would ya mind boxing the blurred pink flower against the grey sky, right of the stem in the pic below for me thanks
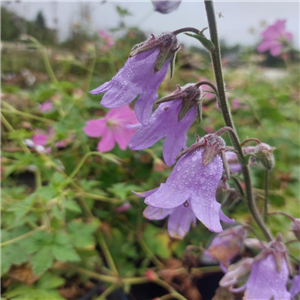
[257,20,293,56]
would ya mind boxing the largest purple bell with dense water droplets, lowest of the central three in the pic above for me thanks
[136,134,233,232]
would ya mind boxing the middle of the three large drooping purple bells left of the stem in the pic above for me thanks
[129,84,201,166]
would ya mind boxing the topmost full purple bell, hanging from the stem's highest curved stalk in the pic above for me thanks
[90,32,180,124]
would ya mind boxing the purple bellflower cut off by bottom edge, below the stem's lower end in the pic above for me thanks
[231,235,291,300]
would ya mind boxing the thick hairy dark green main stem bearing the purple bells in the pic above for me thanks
[204,0,272,241]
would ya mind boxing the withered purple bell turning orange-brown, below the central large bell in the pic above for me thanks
[205,225,247,268]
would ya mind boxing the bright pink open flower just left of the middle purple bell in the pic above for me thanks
[83,105,138,152]
